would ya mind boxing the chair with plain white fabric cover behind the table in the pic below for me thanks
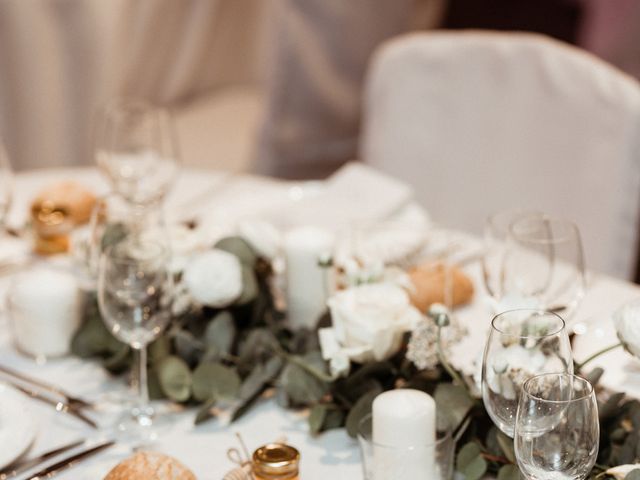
[360,31,640,278]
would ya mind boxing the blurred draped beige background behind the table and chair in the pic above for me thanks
[0,0,640,178]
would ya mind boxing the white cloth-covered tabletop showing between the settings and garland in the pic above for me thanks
[0,167,640,480]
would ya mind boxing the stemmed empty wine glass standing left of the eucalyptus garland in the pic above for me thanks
[98,239,172,429]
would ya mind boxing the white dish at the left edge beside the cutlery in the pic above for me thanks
[0,383,36,468]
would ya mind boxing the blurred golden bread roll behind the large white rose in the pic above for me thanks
[408,263,473,312]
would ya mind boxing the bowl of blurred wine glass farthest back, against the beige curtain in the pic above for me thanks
[94,99,178,205]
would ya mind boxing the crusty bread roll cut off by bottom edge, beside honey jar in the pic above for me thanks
[104,452,196,480]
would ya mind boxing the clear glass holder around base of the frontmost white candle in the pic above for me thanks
[358,415,456,480]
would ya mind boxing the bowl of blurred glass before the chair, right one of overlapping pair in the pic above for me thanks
[502,214,586,317]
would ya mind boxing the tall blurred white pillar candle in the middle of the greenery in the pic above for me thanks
[284,227,334,328]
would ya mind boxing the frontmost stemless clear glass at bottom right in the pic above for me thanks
[515,373,600,480]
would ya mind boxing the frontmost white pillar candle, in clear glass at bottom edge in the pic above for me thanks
[372,389,437,480]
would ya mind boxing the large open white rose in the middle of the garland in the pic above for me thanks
[320,283,422,376]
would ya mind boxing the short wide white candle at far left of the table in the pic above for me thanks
[8,267,82,359]
